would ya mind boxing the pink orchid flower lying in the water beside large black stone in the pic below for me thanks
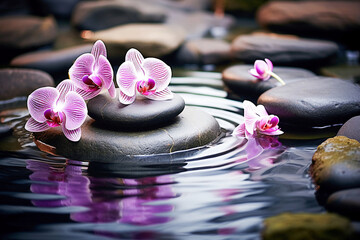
[233,100,283,138]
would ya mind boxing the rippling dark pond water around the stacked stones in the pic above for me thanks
[0,71,331,240]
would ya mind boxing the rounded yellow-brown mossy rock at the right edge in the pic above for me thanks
[311,136,360,192]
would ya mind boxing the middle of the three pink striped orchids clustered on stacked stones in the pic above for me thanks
[69,40,116,100]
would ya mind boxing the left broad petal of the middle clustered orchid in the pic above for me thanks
[69,53,95,89]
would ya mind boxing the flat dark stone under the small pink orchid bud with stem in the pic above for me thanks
[222,65,315,100]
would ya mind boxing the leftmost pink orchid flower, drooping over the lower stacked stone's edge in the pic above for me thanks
[25,80,87,142]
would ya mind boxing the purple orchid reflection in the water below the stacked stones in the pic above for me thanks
[27,160,176,225]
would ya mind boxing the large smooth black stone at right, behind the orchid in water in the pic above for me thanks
[258,77,360,127]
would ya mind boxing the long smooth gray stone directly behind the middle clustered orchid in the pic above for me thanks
[10,44,92,82]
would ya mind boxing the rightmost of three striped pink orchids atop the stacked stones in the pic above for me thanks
[116,48,173,104]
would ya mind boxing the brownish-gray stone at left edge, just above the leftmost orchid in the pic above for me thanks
[0,68,54,100]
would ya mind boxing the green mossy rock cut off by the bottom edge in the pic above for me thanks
[262,213,353,240]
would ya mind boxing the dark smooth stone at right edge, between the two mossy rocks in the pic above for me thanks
[325,188,360,219]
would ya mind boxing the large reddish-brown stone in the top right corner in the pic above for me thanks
[256,0,360,46]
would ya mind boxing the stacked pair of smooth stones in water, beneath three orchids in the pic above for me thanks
[34,91,220,165]
